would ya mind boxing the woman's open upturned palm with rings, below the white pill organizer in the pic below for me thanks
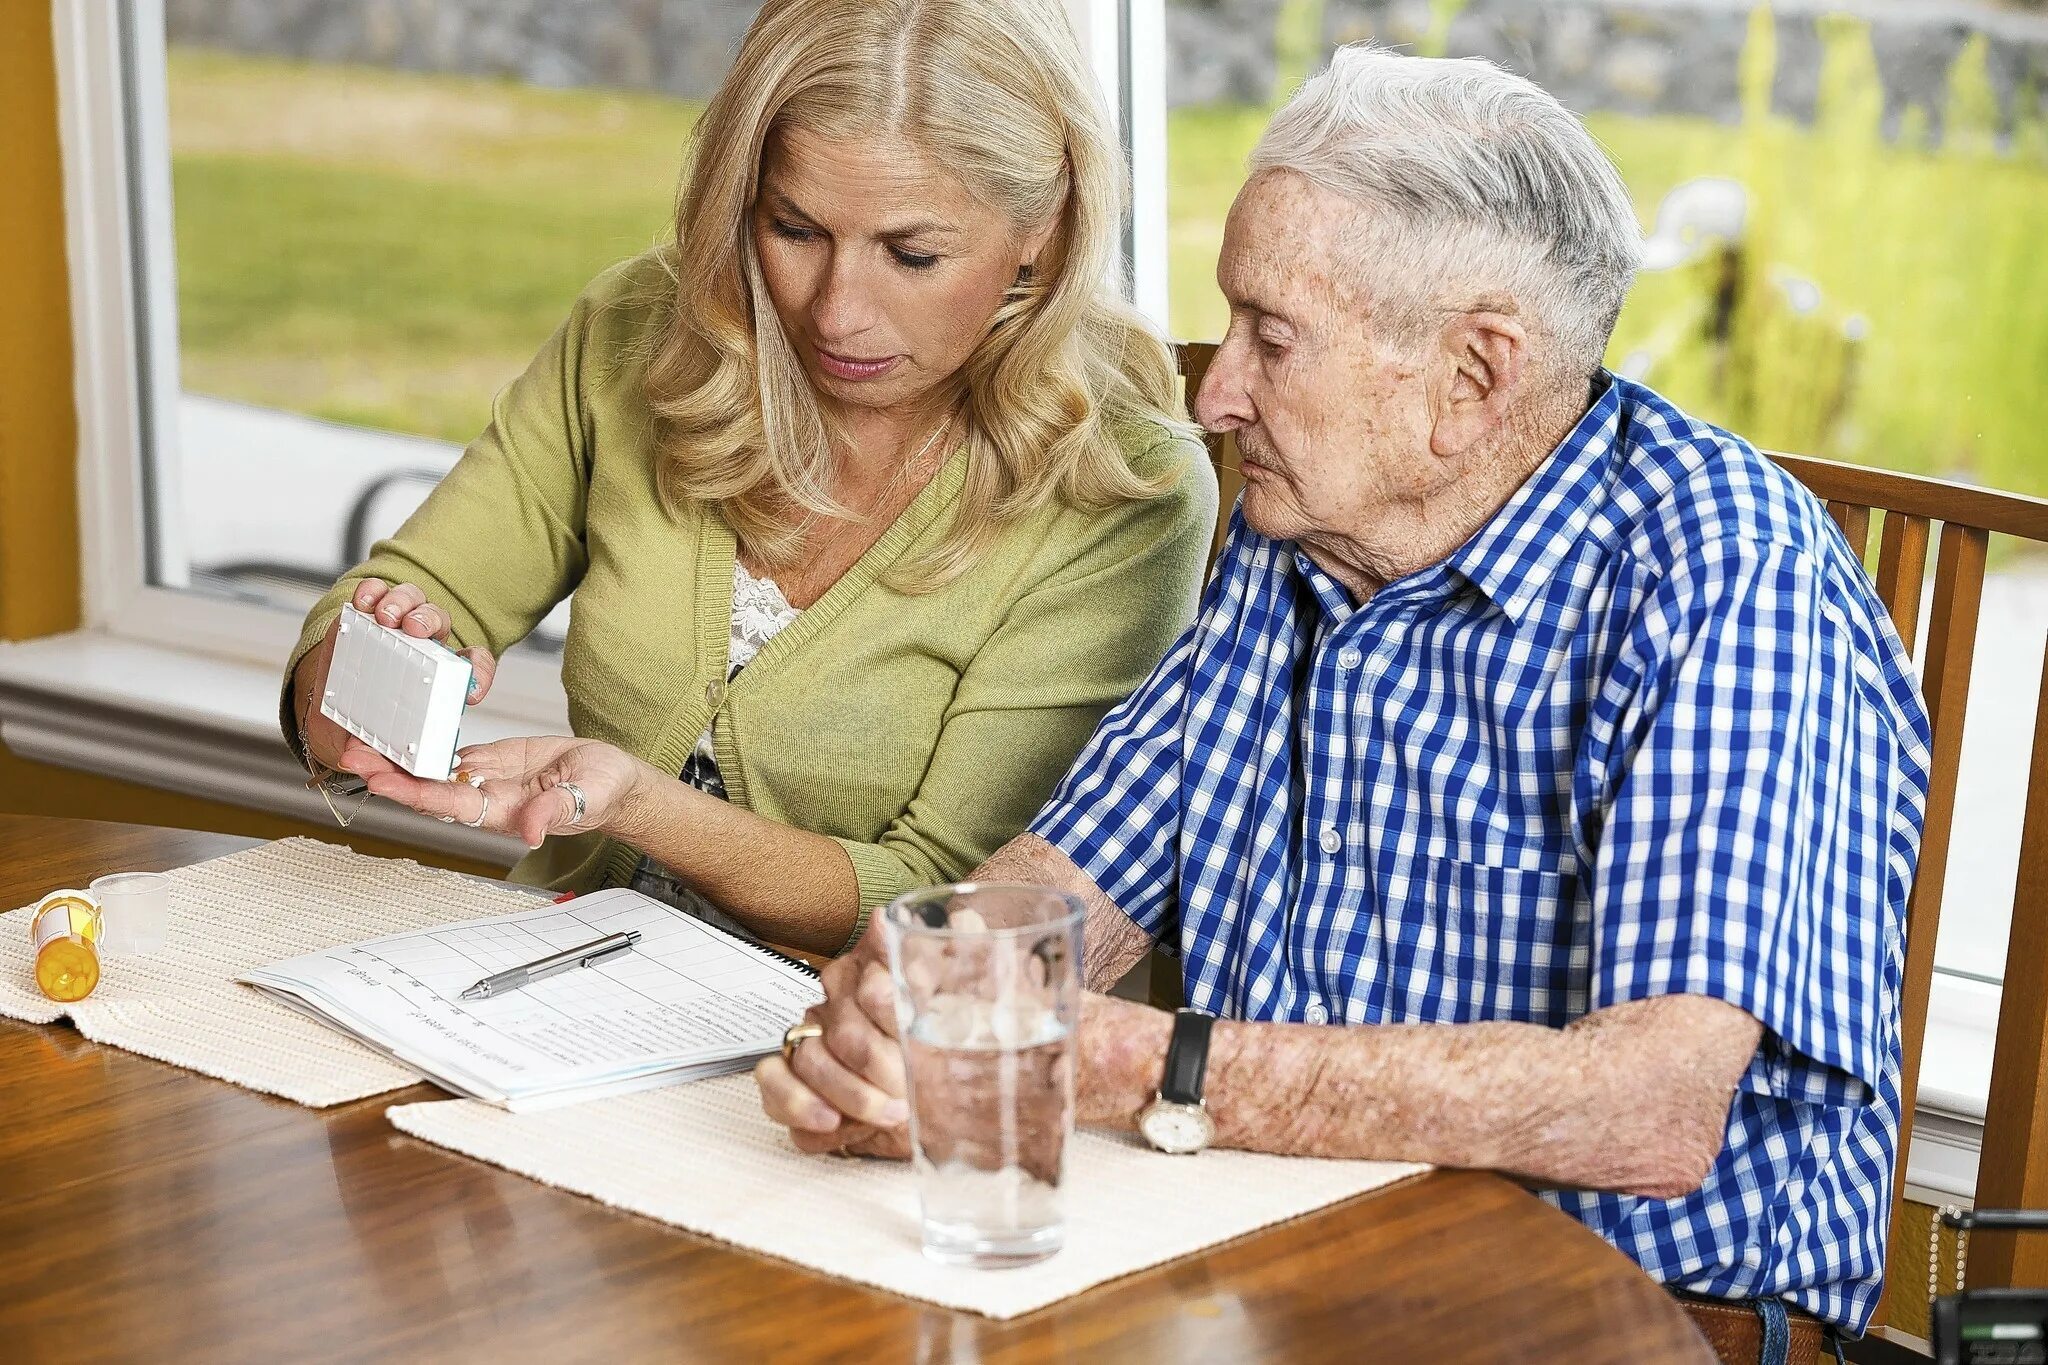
[340,737,651,849]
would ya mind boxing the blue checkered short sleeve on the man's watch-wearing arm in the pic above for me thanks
[1581,540,1925,1105]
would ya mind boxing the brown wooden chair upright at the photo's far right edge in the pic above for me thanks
[1970,642,2048,1287]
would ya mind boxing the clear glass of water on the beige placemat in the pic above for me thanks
[883,884,1081,1269]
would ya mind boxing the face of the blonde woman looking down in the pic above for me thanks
[754,131,1051,423]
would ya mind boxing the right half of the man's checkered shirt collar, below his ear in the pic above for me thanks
[1442,370,1622,626]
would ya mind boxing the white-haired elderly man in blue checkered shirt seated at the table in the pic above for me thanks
[758,49,1927,1359]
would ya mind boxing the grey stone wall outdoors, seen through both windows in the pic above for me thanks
[166,0,2048,137]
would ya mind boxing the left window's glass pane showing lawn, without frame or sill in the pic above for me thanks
[135,0,778,649]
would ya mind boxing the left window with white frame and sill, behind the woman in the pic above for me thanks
[28,0,1138,857]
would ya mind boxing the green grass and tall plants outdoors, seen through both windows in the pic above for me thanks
[170,36,2048,493]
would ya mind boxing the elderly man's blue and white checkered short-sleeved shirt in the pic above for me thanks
[1032,377,1929,1330]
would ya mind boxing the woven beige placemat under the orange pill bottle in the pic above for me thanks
[0,839,535,1107]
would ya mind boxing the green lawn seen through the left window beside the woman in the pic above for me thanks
[170,51,696,440]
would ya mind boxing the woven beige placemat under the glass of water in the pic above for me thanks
[385,1076,1427,1318]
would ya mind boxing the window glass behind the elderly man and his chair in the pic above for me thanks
[1165,0,2048,1002]
